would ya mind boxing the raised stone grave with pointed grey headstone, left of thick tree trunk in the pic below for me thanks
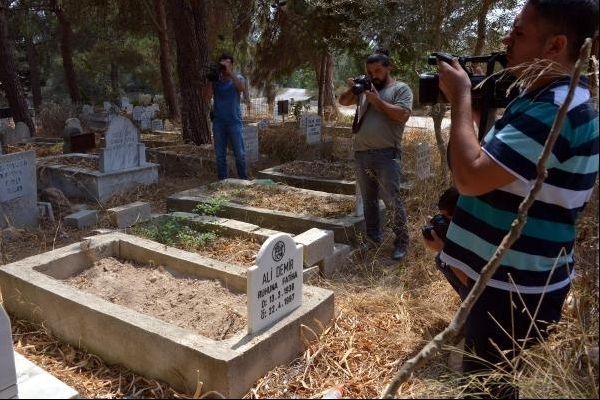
[37,116,158,202]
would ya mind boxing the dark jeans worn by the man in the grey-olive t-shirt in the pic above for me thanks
[354,148,408,250]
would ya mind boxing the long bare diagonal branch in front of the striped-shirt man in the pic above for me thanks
[381,38,592,398]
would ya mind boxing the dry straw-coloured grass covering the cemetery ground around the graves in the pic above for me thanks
[0,126,598,398]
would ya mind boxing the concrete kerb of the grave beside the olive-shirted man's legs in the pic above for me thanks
[167,188,370,244]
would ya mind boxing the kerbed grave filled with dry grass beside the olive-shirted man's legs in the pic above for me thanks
[167,179,384,244]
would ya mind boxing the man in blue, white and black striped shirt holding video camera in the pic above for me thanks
[438,0,598,396]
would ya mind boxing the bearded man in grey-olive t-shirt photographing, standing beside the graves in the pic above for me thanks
[339,50,413,260]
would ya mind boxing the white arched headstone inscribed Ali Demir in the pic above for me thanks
[246,233,303,335]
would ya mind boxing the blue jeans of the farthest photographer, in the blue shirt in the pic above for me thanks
[213,122,248,180]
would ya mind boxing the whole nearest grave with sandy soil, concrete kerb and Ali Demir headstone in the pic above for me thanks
[0,233,333,398]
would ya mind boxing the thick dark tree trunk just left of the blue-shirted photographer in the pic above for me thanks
[169,0,211,145]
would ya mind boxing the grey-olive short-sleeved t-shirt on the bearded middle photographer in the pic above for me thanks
[354,81,413,151]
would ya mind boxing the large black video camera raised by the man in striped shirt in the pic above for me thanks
[419,52,517,109]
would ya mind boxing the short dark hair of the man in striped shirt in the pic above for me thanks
[527,0,598,61]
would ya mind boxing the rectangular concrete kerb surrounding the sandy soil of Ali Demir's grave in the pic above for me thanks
[0,233,333,397]
